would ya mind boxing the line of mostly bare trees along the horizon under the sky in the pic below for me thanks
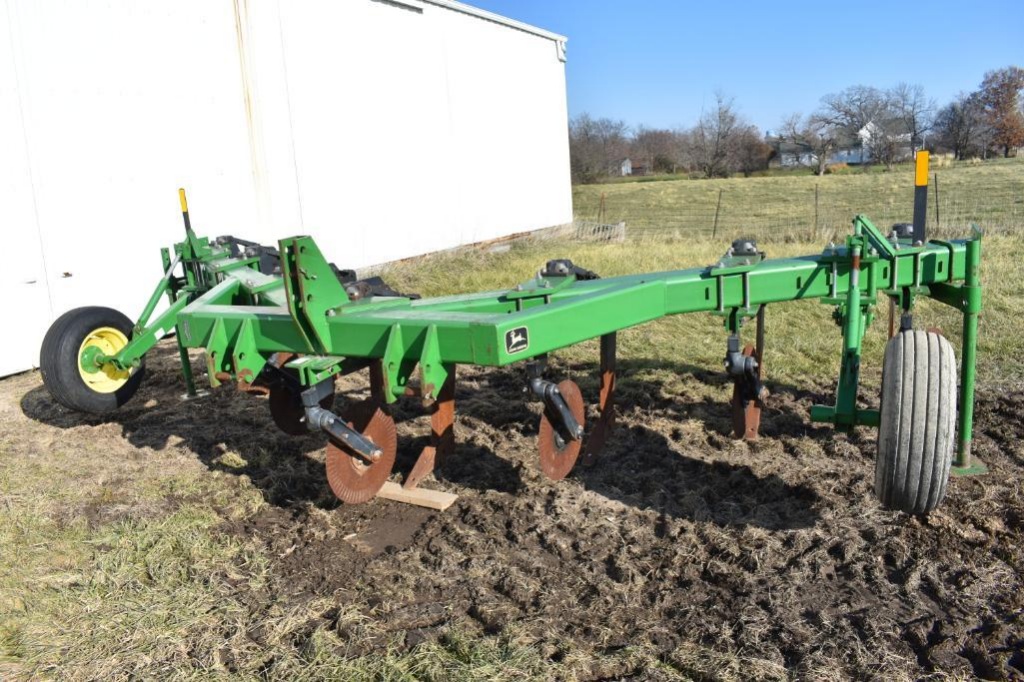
[569,67,1024,182]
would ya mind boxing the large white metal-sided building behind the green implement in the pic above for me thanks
[0,0,571,376]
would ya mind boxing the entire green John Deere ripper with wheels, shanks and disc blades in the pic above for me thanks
[40,153,981,513]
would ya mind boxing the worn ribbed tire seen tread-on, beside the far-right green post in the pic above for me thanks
[874,331,956,514]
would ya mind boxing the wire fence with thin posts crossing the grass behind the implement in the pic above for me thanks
[575,176,1024,241]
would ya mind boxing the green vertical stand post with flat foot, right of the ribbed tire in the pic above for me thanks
[953,236,987,475]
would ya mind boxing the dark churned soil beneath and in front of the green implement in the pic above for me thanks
[16,342,1024,679]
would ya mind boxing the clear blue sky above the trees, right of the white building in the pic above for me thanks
[468,0,1024,130]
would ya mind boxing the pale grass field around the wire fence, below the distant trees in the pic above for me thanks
[573,159,1024,241]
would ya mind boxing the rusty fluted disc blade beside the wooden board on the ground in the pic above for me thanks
[327,398,398,505]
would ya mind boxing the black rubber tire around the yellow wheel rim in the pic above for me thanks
[39,306,145,415]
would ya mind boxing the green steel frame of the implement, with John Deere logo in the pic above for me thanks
[88,209,981,473]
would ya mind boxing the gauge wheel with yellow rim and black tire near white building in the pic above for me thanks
[39,306,145,415]
